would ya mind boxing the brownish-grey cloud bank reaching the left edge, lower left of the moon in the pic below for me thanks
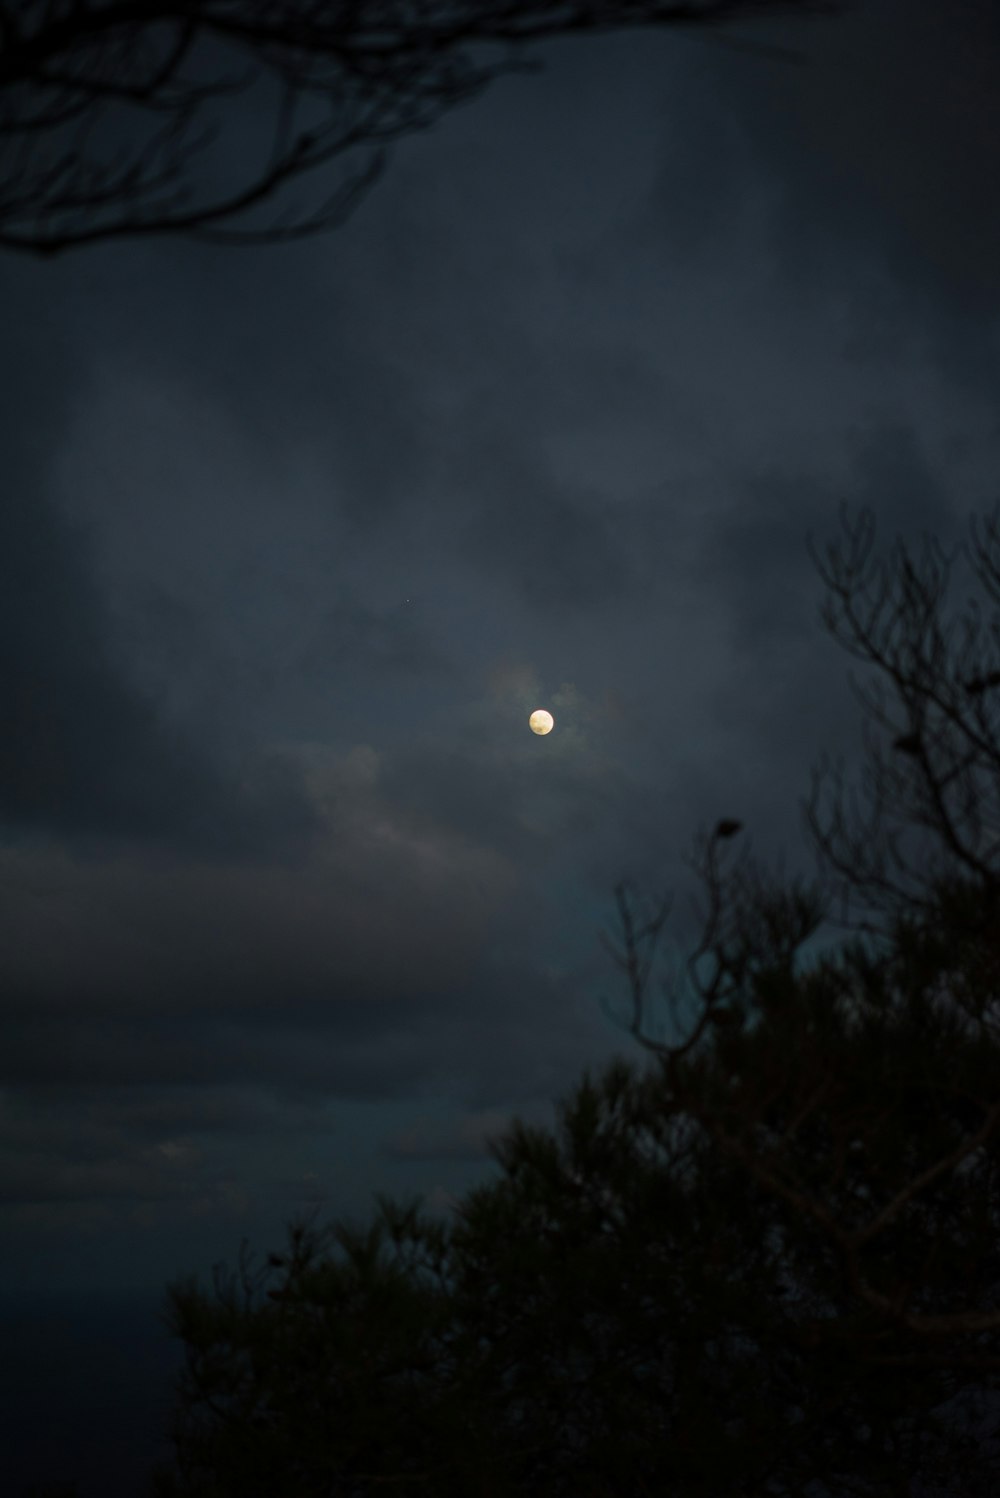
[3,750,512,1030]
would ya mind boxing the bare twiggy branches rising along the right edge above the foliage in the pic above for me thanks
[805,509,1000,935]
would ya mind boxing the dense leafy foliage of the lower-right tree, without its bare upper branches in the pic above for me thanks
[148,934,997,1498]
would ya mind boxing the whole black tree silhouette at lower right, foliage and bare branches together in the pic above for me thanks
[148,506,1000,1498]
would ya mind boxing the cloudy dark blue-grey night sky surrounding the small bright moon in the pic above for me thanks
[0,0,1000,1486]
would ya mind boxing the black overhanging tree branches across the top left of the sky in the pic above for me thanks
[0,0,844,255]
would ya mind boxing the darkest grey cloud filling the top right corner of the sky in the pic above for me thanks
[647,0,1000,383]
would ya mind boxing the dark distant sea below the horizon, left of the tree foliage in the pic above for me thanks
[0,1290,184,1498]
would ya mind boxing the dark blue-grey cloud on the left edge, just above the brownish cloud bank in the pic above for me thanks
[0,307,320,855]
